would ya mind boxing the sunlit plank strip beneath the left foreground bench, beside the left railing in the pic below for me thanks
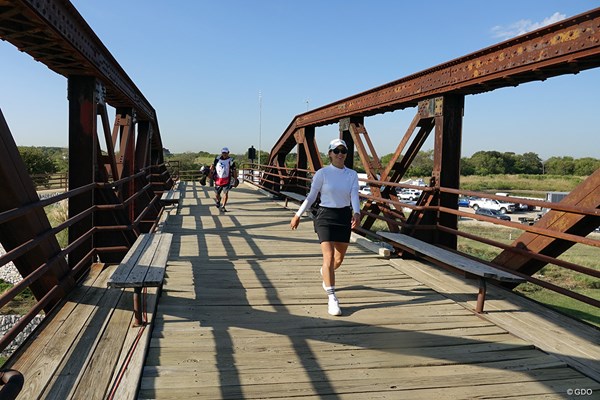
[5,264,162,400]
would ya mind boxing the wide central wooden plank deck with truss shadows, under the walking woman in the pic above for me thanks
[139,184,600,400]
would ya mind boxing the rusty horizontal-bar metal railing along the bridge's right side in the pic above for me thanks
[243,164,600,308]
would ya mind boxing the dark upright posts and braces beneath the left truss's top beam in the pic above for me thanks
[69,77,160,268]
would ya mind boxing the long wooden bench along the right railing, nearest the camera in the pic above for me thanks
[377,231,525,313]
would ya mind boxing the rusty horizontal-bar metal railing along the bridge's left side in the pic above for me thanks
[0,164,171,358]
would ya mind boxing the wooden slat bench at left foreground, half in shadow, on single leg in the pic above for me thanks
[107,233,173,326]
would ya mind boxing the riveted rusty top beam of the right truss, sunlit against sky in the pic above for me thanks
[269,8,600,167]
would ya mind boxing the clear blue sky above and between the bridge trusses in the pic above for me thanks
[0,0,600,159]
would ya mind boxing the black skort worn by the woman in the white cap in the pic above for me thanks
[314,207,352,243]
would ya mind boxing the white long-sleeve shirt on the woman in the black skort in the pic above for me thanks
[296,165,360,217]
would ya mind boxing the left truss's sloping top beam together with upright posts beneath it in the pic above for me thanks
[0,0,169,267]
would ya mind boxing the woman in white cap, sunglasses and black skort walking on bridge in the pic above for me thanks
[290,139,360,315]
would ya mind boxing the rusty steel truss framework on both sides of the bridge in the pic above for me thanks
[0,0,600,398]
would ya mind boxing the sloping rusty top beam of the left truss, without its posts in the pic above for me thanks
[0,0,156,122]
